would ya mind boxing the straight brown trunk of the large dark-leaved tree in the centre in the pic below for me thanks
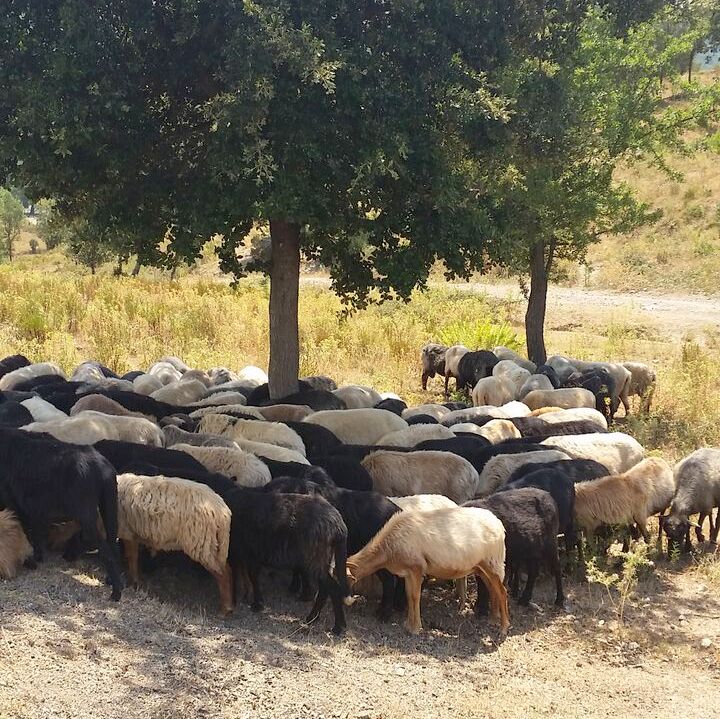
[268,220,300,399]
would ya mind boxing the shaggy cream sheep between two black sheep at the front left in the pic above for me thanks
[117,474,233,614]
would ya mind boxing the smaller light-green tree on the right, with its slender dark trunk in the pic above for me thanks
[478,8,720,363]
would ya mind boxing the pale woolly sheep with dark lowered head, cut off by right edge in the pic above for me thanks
[662,447,720,554]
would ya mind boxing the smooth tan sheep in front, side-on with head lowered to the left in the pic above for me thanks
[347,507,510,634]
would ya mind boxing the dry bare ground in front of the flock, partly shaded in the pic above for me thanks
[0,558,720,719]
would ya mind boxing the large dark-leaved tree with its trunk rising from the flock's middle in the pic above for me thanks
[0,0,516,397]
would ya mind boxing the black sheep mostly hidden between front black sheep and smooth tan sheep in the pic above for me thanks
[262,472,400,621]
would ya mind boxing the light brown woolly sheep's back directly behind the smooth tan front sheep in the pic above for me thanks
[362,450,479,504]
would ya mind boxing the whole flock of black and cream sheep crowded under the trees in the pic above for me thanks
[0,344,720,634]
